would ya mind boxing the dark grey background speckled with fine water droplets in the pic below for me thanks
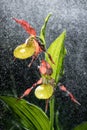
[0,0,87,130]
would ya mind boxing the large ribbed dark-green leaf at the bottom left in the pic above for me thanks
[0,96,50,130]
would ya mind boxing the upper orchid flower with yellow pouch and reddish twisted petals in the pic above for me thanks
[13,18,54,67]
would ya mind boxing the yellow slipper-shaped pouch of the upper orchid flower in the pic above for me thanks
[13,43,35,59]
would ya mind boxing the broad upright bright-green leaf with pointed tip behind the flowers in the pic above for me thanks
[46,31,66,83]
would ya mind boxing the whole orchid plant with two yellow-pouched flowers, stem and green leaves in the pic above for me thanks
[0,14,80,130]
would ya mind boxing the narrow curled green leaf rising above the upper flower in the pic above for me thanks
[40,13,51,45]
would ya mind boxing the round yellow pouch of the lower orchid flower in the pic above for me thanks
[35,84,53,99]
